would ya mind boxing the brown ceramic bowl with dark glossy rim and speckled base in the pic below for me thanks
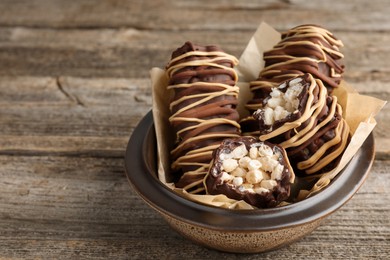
[125,112,374,253]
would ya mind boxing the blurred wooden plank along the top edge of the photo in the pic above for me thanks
[0,0,390,31]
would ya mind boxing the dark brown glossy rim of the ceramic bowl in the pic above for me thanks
[125,111,375,232]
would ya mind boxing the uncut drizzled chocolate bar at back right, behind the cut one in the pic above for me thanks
[240,24,344,135]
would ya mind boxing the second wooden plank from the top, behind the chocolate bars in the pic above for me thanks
[0,27,390,78]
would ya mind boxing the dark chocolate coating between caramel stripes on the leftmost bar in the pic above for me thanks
[170,42,239,164]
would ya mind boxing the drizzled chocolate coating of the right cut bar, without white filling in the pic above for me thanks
[253,74,347,175]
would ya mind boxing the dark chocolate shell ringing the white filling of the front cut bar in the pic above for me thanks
[204,137,294,208]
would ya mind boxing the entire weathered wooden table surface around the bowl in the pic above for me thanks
[0,0,390,259]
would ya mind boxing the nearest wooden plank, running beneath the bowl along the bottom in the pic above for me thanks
[0,156,390,259]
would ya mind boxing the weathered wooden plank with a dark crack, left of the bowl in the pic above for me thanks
[0,77,151,137]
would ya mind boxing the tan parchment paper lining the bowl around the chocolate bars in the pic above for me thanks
[150,23,386,209]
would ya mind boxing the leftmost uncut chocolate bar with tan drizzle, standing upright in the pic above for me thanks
[167,42,240,191]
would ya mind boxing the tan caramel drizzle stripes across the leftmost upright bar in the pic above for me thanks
[167,51,240,194]
